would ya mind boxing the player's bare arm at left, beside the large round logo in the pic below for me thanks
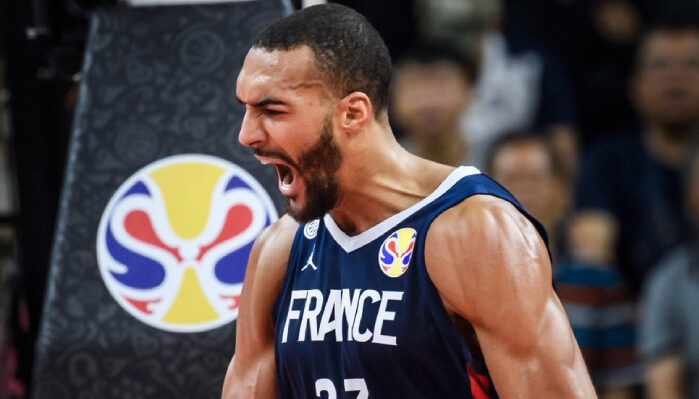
[221,216,297,399]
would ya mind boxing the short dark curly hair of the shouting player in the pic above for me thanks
[252,4,392,115]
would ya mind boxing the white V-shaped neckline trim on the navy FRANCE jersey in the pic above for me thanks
[323,166,481,253]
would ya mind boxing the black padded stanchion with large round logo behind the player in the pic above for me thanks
[32,0,290,399]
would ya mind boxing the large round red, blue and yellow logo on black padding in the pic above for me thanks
[97,154,277,332]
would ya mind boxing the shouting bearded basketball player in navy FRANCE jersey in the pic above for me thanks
[223,5,595,399]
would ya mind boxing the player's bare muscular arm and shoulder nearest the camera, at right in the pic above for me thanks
[425,196,596,398]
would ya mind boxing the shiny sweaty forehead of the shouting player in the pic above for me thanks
[237,46,324,102]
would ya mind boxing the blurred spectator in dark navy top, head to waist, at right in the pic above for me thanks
[570,24,699,293]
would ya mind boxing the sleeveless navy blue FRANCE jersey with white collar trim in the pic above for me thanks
[273,167,545,399]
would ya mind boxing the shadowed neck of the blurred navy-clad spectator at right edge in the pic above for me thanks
[648,125,694,168]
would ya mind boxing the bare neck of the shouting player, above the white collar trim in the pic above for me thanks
[330,128,453,235]
